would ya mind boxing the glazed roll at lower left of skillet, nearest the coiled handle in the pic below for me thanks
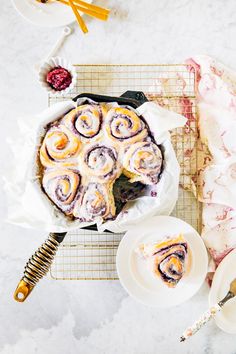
[42,169,80,215]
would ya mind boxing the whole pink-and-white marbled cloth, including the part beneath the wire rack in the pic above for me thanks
[147,56,236,272]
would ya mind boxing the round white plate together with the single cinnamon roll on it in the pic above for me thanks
[116,216,208,307]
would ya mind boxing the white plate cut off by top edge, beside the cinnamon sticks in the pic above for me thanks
[12,0,92,27]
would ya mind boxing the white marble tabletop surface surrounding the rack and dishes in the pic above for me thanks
[0,0,236,354]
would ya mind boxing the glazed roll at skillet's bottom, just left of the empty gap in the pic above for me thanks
[73,183,116,221]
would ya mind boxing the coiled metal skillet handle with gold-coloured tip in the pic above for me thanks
[14,232,66,302]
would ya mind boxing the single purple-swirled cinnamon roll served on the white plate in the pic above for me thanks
[139,235,191,288]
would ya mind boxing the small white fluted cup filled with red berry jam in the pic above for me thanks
[39,57,76,95]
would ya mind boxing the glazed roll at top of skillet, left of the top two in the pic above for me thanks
[63,104,106,138]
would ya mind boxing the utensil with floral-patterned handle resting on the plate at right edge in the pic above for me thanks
[180,278,236,342]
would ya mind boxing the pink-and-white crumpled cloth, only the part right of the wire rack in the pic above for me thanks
[187,56,236,271]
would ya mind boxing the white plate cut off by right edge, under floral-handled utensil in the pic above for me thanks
[209,250,236,333]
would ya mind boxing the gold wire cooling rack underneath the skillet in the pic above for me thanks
[49,64,201,280]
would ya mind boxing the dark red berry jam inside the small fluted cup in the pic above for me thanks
[46,66,72,91]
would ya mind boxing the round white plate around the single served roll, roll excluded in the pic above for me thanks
[116,216,208,307]
